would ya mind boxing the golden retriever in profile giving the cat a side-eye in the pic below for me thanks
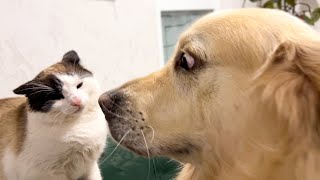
[99,9,320,180]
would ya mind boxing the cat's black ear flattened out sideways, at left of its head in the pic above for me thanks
[13,80,45,97]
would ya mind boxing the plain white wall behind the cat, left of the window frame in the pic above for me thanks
[0,0,160,98]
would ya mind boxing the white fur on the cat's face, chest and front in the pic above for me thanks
[2,75,108,180]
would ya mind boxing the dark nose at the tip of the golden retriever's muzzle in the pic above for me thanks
[99,91,124,121]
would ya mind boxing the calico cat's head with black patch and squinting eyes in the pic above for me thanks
[13,51,98,115]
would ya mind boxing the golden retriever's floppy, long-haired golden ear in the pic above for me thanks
[255,41,320,140]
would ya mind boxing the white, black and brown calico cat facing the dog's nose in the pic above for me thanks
[0,51,108,180]
